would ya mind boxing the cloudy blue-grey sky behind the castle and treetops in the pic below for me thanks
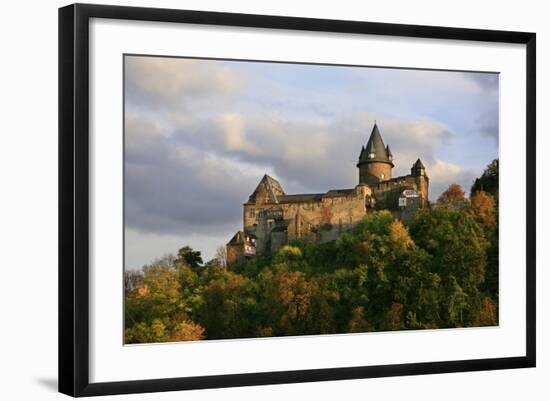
[124,56,499,269]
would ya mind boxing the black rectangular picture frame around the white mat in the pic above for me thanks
[59,4,536,396]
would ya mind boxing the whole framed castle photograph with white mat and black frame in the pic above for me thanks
[59,4,536,396]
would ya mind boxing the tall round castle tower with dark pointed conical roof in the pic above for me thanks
[357,122,393,186]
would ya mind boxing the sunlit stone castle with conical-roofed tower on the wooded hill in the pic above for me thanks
[226,122,429,265]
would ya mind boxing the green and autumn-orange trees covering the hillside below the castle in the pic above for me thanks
[125,161,498,343]
